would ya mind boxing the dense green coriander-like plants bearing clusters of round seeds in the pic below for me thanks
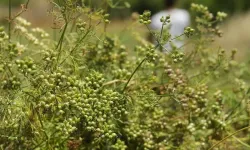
[0,0,250,150]
